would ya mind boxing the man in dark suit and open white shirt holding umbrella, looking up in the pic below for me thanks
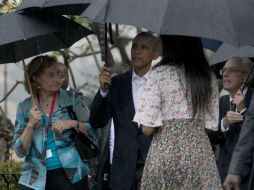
[90,32,159,190]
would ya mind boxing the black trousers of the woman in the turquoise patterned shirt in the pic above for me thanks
[18,168,89,190]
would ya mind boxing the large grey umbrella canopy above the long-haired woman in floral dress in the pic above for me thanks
[81,0,254,46]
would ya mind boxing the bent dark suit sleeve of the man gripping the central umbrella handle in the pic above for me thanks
[89,90,111,129]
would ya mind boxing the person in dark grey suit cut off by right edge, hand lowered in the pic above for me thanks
[223,95,254,190]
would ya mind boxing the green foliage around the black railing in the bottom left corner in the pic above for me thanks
[0,160,23,190]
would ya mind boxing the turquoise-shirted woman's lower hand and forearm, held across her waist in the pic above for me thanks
[52,120,78,133]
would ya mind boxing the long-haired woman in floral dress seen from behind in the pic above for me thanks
[134,36,221,190]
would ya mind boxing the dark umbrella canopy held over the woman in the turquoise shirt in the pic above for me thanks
[0,11,92,64]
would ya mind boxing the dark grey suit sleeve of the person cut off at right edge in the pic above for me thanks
[228,93,254,178]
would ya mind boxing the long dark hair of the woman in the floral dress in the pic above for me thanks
[159,35,212,117]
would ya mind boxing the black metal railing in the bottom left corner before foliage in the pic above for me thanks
[0,173,20,190]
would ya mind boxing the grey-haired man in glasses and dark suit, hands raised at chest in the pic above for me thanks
[209,57,253,189]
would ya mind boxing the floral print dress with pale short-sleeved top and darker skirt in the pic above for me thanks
[134,65,222,190]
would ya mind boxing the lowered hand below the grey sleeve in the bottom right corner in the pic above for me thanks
[223,174,242,190]
